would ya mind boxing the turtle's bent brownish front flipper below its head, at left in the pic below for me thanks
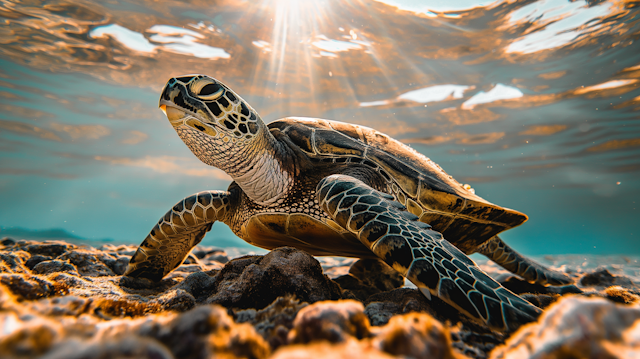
[124,191,230,282]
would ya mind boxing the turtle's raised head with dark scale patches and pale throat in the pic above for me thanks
[159,75,268,173]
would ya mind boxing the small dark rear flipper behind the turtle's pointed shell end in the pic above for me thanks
[476,236,573,285]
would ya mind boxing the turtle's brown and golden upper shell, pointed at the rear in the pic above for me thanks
[268,117,527,254]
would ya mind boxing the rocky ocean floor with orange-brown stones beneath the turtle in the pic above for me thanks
[0,238,640,359]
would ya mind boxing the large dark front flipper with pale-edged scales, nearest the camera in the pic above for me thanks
[316,175,542,331]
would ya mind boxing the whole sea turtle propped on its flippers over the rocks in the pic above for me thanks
[125,75,571,330]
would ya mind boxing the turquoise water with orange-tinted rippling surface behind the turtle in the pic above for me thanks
[0,0,640,255]
